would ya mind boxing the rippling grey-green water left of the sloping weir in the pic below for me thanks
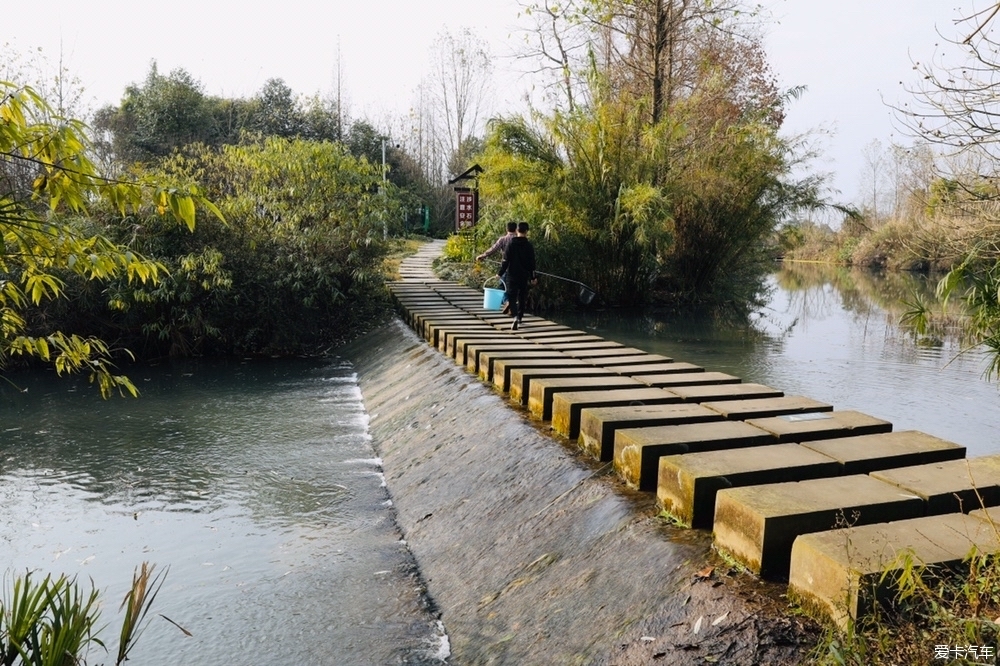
[0,361,446,665]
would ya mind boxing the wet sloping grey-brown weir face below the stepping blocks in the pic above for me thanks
[341,321,815,665]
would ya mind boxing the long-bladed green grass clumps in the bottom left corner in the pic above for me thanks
[0,562,166,666]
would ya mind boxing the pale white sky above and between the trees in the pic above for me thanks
[0,0,986,202]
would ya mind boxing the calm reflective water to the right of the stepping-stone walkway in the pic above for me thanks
[555,264,1000,455]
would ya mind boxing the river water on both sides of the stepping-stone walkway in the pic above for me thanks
[0,266,1000,666]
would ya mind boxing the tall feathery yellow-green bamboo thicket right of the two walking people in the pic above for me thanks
[460,70,820,305]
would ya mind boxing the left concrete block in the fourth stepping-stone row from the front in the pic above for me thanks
[614,422,774,490]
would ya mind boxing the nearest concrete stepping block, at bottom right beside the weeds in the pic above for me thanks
[788,514,1000,630]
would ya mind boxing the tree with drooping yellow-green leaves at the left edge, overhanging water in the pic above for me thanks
[0,83,218,397]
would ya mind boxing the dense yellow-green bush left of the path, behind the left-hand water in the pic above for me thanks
[100,137,394,355]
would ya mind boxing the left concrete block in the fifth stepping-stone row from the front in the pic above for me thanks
[580,405,722,462]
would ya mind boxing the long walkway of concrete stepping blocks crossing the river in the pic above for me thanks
[390,243,1000,624]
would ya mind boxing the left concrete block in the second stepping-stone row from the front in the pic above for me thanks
[713,474,924,579]
